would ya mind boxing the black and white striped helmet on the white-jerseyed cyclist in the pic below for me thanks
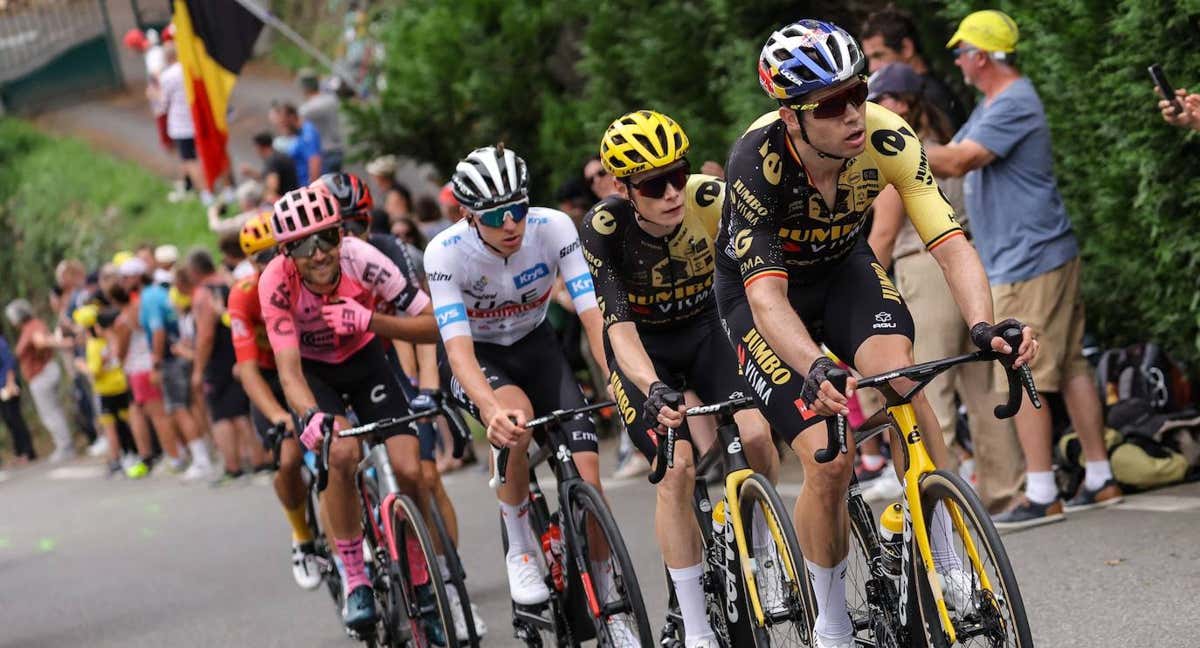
[450,144,529,211]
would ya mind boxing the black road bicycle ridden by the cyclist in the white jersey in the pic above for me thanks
[491,402,654,648]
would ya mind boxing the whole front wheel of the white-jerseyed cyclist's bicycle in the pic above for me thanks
[568,482,654,648]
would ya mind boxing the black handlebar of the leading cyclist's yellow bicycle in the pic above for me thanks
[814,326,1042,463]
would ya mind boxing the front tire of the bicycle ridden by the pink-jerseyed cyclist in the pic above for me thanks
[388,494,460,648]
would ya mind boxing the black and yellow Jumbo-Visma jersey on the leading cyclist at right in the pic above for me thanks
[718,103,962,286]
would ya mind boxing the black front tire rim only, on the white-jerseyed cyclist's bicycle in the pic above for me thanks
[566,482,654,647]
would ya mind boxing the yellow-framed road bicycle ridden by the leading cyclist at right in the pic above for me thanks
[815,328,1042,648]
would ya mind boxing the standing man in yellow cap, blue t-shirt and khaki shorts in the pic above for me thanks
[926,11,1122,528]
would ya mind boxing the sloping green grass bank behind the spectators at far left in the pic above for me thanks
[0,119,214,316]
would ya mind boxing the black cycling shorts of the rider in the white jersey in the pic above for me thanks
[438,322,599,452]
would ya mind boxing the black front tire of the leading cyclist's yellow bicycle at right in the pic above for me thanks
[913,470,1033,648]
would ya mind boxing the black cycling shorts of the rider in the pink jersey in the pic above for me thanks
[301,336,416,436]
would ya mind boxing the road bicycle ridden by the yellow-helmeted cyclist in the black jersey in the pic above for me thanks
[649,396,816,648]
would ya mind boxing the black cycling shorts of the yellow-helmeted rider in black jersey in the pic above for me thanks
[604,313,750,463]
